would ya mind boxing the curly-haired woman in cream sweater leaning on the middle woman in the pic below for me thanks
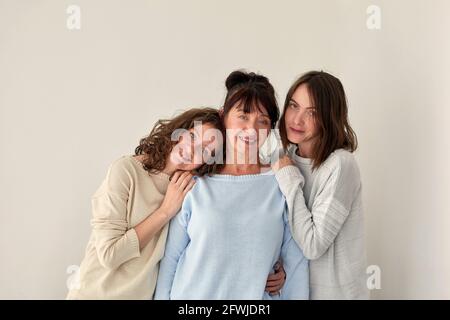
[67,108,284,299]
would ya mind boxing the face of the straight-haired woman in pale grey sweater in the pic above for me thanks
[285,84,318,144]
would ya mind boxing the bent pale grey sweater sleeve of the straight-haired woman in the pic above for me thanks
[276,157,361,260]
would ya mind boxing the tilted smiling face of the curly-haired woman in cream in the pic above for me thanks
[170,123,221,171]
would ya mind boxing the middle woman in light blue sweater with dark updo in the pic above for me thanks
[155,71,309,299]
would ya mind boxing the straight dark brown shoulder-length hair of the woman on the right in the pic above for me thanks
[279,71,358,169]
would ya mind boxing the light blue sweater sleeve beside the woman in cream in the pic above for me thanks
[154,202,190,300]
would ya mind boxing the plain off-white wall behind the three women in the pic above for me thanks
[0,0,450,299]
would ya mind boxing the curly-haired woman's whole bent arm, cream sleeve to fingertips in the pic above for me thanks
[91,161,193,269]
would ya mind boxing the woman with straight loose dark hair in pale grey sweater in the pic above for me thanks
[273,71,369,299]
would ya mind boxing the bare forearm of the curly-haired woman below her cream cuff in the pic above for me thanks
[134,207,171,250]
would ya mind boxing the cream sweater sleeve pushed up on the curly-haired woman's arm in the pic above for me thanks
[91,160,140,269]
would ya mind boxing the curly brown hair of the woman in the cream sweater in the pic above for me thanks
[134,108,224,175]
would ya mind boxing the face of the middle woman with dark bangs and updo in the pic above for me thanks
[224,103,271,158]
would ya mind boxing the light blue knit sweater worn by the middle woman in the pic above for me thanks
[154,174,309,300]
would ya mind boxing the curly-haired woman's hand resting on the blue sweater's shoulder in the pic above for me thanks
[160,171,195,219]
